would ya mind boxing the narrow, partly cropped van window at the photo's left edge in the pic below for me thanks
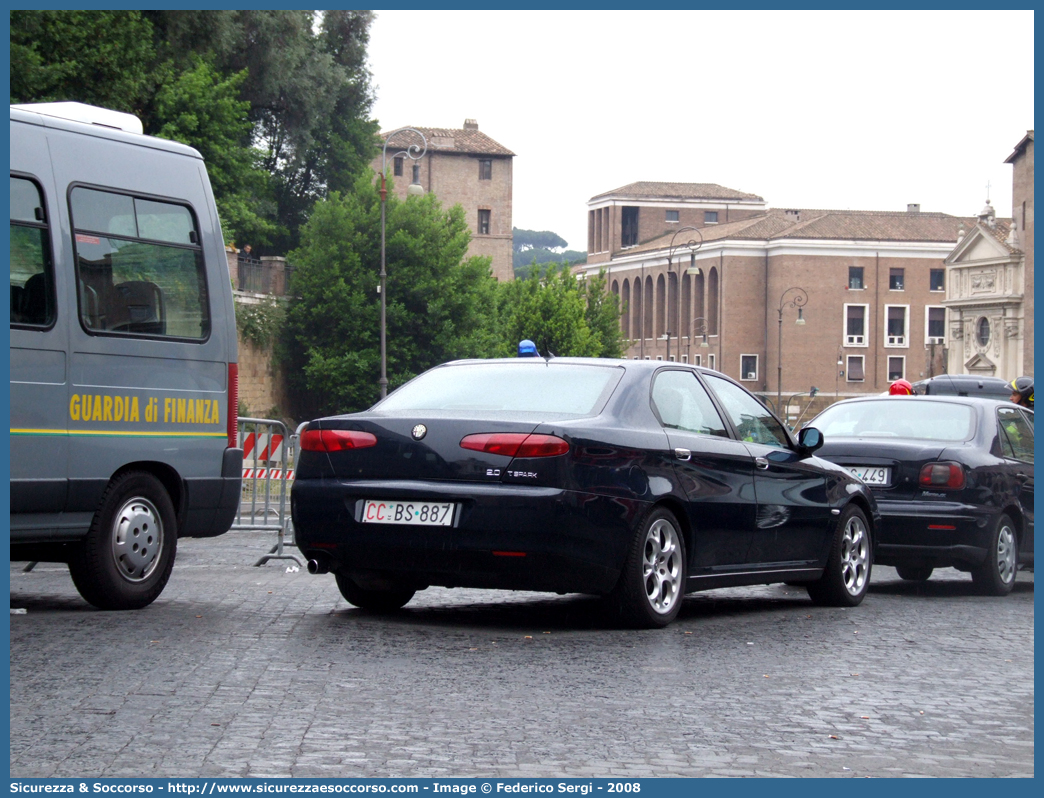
[10,177,55,327]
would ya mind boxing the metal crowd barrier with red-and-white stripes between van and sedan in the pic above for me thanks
[231,418,302,567]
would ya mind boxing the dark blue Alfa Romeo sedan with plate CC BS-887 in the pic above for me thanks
[291,357,878,627]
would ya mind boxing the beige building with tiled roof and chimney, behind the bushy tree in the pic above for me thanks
[373,119,515,280]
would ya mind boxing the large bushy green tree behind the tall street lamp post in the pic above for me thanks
[283,170,497,417]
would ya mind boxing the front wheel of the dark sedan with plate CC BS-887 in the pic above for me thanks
[806,504,874,607]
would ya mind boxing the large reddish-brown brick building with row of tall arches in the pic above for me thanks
[579,183,975,399]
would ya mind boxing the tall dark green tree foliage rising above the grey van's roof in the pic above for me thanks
[10,9,377,254]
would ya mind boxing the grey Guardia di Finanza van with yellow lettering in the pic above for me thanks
[10,102,242,610]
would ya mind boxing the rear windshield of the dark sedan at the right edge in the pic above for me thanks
[812,397,975,442]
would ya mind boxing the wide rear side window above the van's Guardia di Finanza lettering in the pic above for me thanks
[70,187,210,339]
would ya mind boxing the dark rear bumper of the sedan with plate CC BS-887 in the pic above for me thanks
[290,479,647,593]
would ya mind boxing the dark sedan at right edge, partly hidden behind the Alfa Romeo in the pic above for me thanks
[810,396,1034,595]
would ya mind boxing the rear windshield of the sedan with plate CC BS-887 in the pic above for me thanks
[374,361,623,418]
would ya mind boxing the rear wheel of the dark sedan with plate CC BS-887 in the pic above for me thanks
[611,508,686,629]
